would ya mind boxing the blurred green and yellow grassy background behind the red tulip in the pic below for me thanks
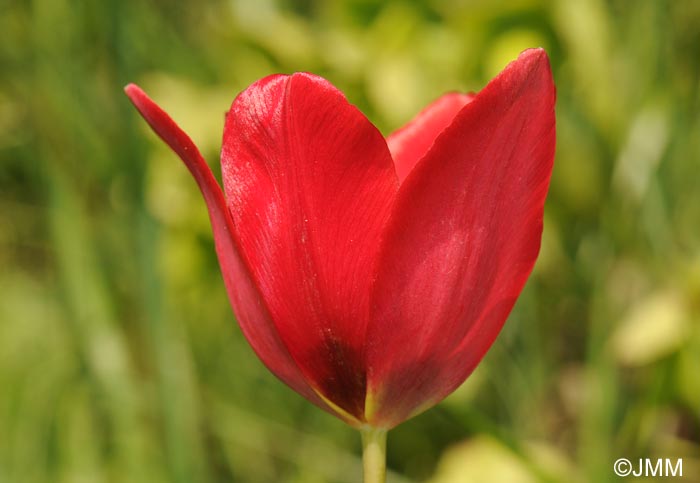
[0,0,700,483]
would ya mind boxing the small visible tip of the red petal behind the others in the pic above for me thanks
[386,92,474,183]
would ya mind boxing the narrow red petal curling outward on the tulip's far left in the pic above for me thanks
[124,84,352,422]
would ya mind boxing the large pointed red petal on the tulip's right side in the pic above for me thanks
[366,49,555,427]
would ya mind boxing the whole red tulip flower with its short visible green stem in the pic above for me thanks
[125,49,555,481]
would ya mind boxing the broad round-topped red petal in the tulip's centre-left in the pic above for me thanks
[221,74,398,421]
